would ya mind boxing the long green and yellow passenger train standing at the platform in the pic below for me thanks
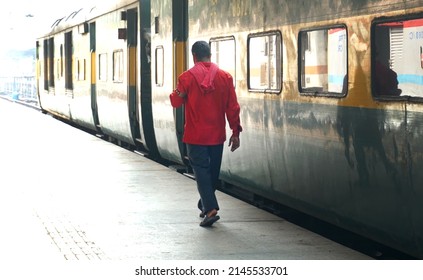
[36,0,423,259]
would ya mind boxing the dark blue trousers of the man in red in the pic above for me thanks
[187,144,223,213]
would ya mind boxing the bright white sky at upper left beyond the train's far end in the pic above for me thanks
[0,0,94,77]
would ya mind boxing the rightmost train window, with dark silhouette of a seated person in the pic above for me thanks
[372,18,423,98]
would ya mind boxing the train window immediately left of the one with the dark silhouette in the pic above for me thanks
[299,26,348,96]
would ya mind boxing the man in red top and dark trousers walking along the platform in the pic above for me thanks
[170,41,242,227]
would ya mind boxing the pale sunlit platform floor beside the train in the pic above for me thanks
[0,99,369,261]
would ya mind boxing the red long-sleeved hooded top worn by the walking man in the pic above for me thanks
[170,62,242,145]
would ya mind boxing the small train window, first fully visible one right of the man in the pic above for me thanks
[248,32,282,93]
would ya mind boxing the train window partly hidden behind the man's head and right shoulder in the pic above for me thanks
[210,36,236,86]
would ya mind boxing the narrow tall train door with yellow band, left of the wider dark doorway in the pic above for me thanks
[90,22,101,133]
